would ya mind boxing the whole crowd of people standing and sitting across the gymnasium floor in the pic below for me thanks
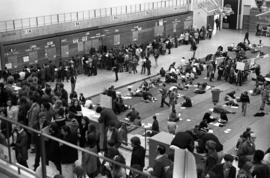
[0,26,270,178]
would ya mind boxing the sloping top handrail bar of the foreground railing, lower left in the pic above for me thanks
[0,116,155,178]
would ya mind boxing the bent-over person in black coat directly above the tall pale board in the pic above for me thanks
[171,131,194,152]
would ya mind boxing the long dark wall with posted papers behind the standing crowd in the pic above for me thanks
[1,12,193,70]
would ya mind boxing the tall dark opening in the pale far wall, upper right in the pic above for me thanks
[223,0,239,29]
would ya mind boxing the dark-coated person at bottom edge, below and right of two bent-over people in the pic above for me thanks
[210,154,236,178]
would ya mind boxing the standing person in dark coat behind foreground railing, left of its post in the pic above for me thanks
[15,122,28,168]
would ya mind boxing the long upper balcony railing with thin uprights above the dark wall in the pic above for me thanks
[0,0,190,32]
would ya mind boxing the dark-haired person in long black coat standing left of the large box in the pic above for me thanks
[130,136,145,171]
